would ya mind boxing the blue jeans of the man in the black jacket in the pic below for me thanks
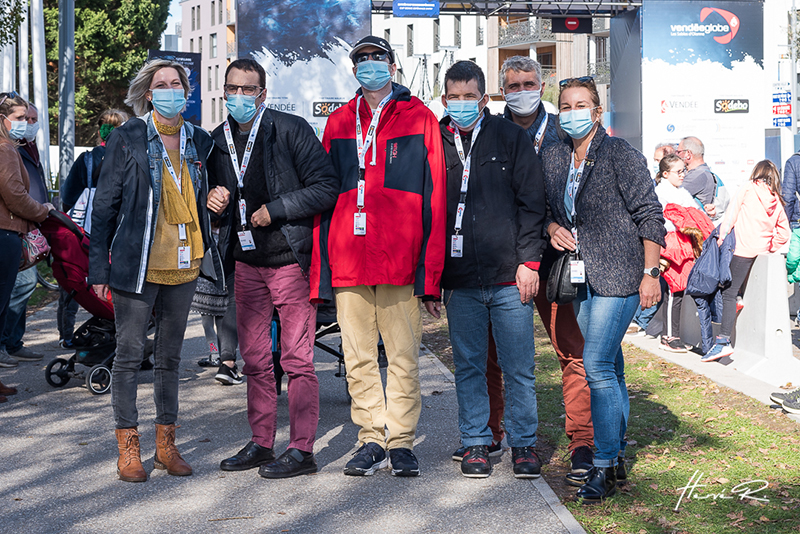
[444,285,539,447]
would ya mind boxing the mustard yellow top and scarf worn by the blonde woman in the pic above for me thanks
[146,150,204,286]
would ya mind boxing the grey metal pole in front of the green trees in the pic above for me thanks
[58,0,75,194]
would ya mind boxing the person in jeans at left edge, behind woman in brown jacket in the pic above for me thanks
[0,103,50,362]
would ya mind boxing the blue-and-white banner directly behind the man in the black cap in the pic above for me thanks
[237,0,372,138]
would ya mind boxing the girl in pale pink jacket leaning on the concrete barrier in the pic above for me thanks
[701,160,791,362]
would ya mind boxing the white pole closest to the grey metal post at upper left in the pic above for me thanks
[30,0,51,189]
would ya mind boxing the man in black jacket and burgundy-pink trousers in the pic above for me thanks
[208,59,339,478]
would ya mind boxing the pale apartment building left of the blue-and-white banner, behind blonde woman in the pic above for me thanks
[180,0,236,131]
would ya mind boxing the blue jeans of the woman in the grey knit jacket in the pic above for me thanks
[573,284,639,467]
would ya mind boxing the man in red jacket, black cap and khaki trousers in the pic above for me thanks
[311,36,447,476]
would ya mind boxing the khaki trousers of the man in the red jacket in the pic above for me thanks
[335,285,422,449]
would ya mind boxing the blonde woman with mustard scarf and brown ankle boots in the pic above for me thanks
[89,59,224,482]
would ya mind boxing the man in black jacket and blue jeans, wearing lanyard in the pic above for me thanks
[426,61,546,478]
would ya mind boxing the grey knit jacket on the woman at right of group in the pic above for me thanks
[542,126,666,297]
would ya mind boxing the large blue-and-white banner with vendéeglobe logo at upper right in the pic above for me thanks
[642,0,770,193]
